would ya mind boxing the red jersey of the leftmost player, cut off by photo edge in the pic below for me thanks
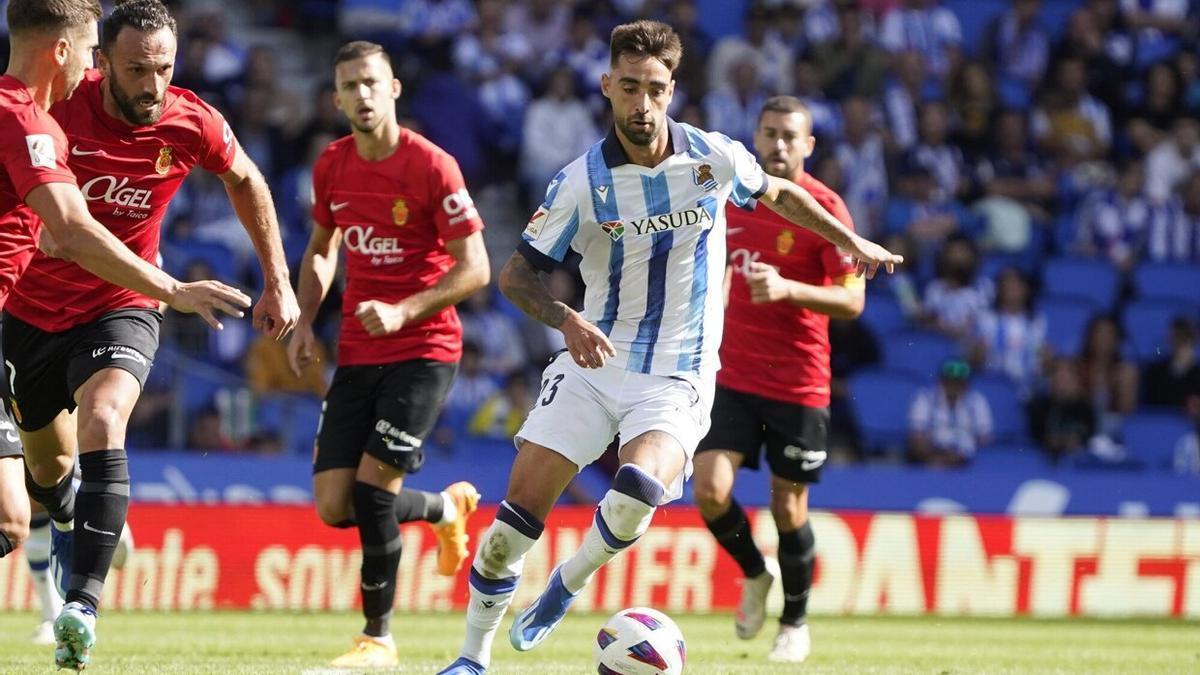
[0,74,74,309]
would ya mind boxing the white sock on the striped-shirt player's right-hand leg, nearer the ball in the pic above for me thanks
[559,480,655,593]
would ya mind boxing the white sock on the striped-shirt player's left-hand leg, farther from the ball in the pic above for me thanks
[460,502,545,668]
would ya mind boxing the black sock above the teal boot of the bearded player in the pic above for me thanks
[66,448,130,609]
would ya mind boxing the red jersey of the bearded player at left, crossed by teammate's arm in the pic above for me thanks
[8,71,238,333]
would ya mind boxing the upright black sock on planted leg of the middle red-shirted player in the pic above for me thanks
[354,482,401,638]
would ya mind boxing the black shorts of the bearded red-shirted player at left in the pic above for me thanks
[4,310,162,431]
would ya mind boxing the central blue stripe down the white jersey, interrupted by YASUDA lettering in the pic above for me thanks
[629,172,674,372]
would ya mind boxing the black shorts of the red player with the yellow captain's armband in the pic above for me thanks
[696,387,829,483]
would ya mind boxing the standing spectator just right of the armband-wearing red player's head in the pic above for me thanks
[833,96,888,239]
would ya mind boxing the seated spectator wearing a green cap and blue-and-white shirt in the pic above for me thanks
[908,359,992,467]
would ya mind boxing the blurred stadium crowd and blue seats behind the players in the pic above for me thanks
[4,0,1200,473]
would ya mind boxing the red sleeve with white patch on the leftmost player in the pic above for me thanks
[0,106,76,199]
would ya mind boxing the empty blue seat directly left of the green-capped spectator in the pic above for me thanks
[850,368,922,454]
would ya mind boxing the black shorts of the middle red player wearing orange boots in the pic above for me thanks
[312,359,458,473]
